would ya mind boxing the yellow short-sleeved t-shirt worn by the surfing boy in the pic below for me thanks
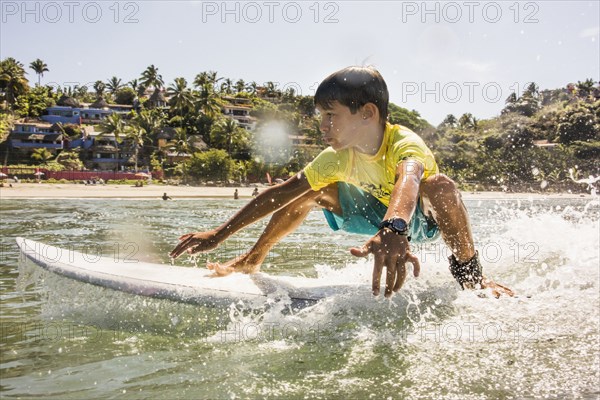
[304,123,439,206]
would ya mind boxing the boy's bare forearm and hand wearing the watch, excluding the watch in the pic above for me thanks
[350,160,423,297]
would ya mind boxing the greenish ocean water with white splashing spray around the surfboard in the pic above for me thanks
[0,195,600,399]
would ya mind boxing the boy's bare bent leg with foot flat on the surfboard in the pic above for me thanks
[207,185,341,276]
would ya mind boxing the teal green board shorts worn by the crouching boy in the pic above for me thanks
[323,182,441,243]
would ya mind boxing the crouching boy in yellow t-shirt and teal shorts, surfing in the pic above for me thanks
[171,67,512,297]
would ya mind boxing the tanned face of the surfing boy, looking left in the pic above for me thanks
[316,101,367,150]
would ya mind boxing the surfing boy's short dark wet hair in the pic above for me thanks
[315,67,390,126]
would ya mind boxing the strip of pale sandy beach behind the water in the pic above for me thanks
[0,183,593,200]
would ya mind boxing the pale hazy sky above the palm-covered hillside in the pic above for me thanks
[0,0,600,125]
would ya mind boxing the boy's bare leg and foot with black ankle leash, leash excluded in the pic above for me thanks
[420,174,514,297]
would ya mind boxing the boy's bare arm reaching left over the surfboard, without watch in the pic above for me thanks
[169,172,312,258]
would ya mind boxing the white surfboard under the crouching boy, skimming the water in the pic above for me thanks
[17,237,360,307]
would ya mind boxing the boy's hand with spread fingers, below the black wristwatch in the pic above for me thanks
[350,228,421,297]
